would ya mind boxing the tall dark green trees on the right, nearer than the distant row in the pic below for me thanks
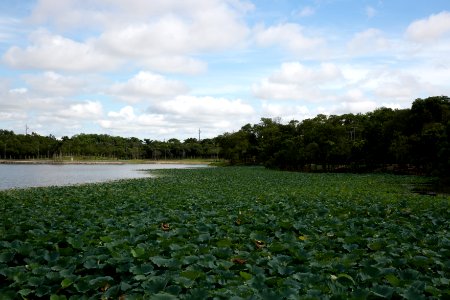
[217,96,450,177]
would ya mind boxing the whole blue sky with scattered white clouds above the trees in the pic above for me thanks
[0,0,450,140]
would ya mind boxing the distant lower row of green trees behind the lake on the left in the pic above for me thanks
[0,130,219,160]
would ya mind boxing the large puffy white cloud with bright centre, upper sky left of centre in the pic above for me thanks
[97,9,248,58]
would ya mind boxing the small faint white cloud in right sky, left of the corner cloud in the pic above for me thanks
[347,28,390,54]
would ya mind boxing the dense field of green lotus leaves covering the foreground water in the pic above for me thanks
[0,167,450,299]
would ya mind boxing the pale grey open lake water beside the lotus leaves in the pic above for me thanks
[0,164,205,190]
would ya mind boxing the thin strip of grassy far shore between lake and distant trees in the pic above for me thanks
[0,159,217,165]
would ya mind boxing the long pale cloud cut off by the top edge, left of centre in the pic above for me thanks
[30,0,253,30]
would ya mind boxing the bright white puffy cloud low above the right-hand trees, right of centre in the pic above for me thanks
[253,62,343,102]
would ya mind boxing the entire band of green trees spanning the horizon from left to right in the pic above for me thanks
[0,96,450,177]
